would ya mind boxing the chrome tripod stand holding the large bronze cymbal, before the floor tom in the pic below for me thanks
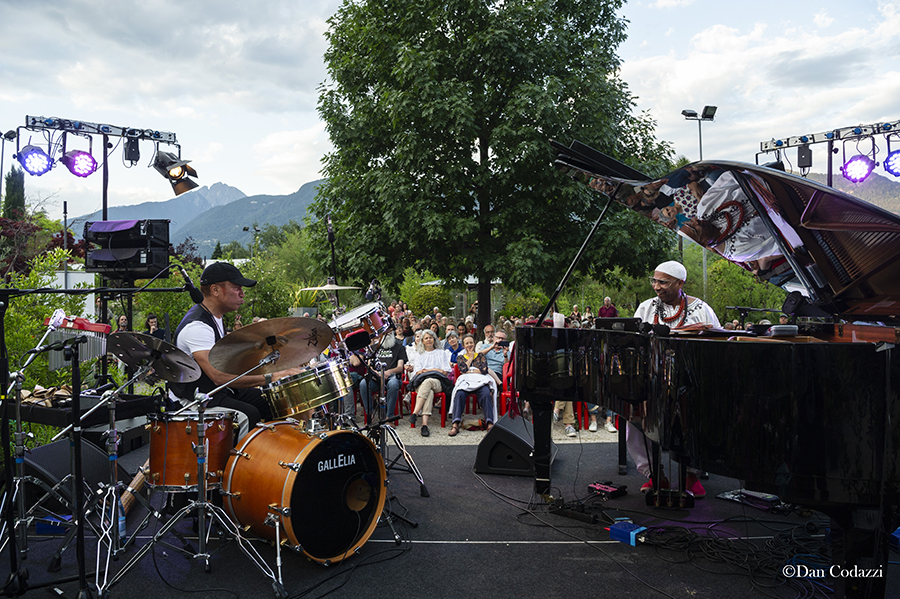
[107,350,287,599]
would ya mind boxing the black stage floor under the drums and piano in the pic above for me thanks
[0,436,900,599]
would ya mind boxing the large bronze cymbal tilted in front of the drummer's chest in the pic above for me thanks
[209,317,332,375]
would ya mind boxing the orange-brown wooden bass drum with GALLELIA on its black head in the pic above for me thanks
[225,422,386,565]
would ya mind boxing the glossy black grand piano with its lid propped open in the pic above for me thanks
[515,142,900,596]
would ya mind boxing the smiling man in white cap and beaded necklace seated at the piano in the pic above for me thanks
[626,260,720,499]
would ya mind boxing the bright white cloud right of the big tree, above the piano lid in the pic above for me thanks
[622,5,900,162]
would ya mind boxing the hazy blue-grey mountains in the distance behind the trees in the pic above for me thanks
[78,172,900,257]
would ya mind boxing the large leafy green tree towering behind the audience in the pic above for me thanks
[311,0,671,325]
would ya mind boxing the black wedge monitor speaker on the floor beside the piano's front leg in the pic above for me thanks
[475,415,559,477]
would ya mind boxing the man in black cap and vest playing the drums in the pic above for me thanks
[169,262,300,438]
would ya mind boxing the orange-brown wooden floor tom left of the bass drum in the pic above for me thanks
[147,412,234,492]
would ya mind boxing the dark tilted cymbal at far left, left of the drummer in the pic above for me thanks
[106,331,202,383]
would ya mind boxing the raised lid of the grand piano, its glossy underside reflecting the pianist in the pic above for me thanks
[552,142,900,320]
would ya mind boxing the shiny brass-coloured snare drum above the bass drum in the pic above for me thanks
[263,362,353,419]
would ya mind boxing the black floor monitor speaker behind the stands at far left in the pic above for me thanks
[24,439,132,513]
